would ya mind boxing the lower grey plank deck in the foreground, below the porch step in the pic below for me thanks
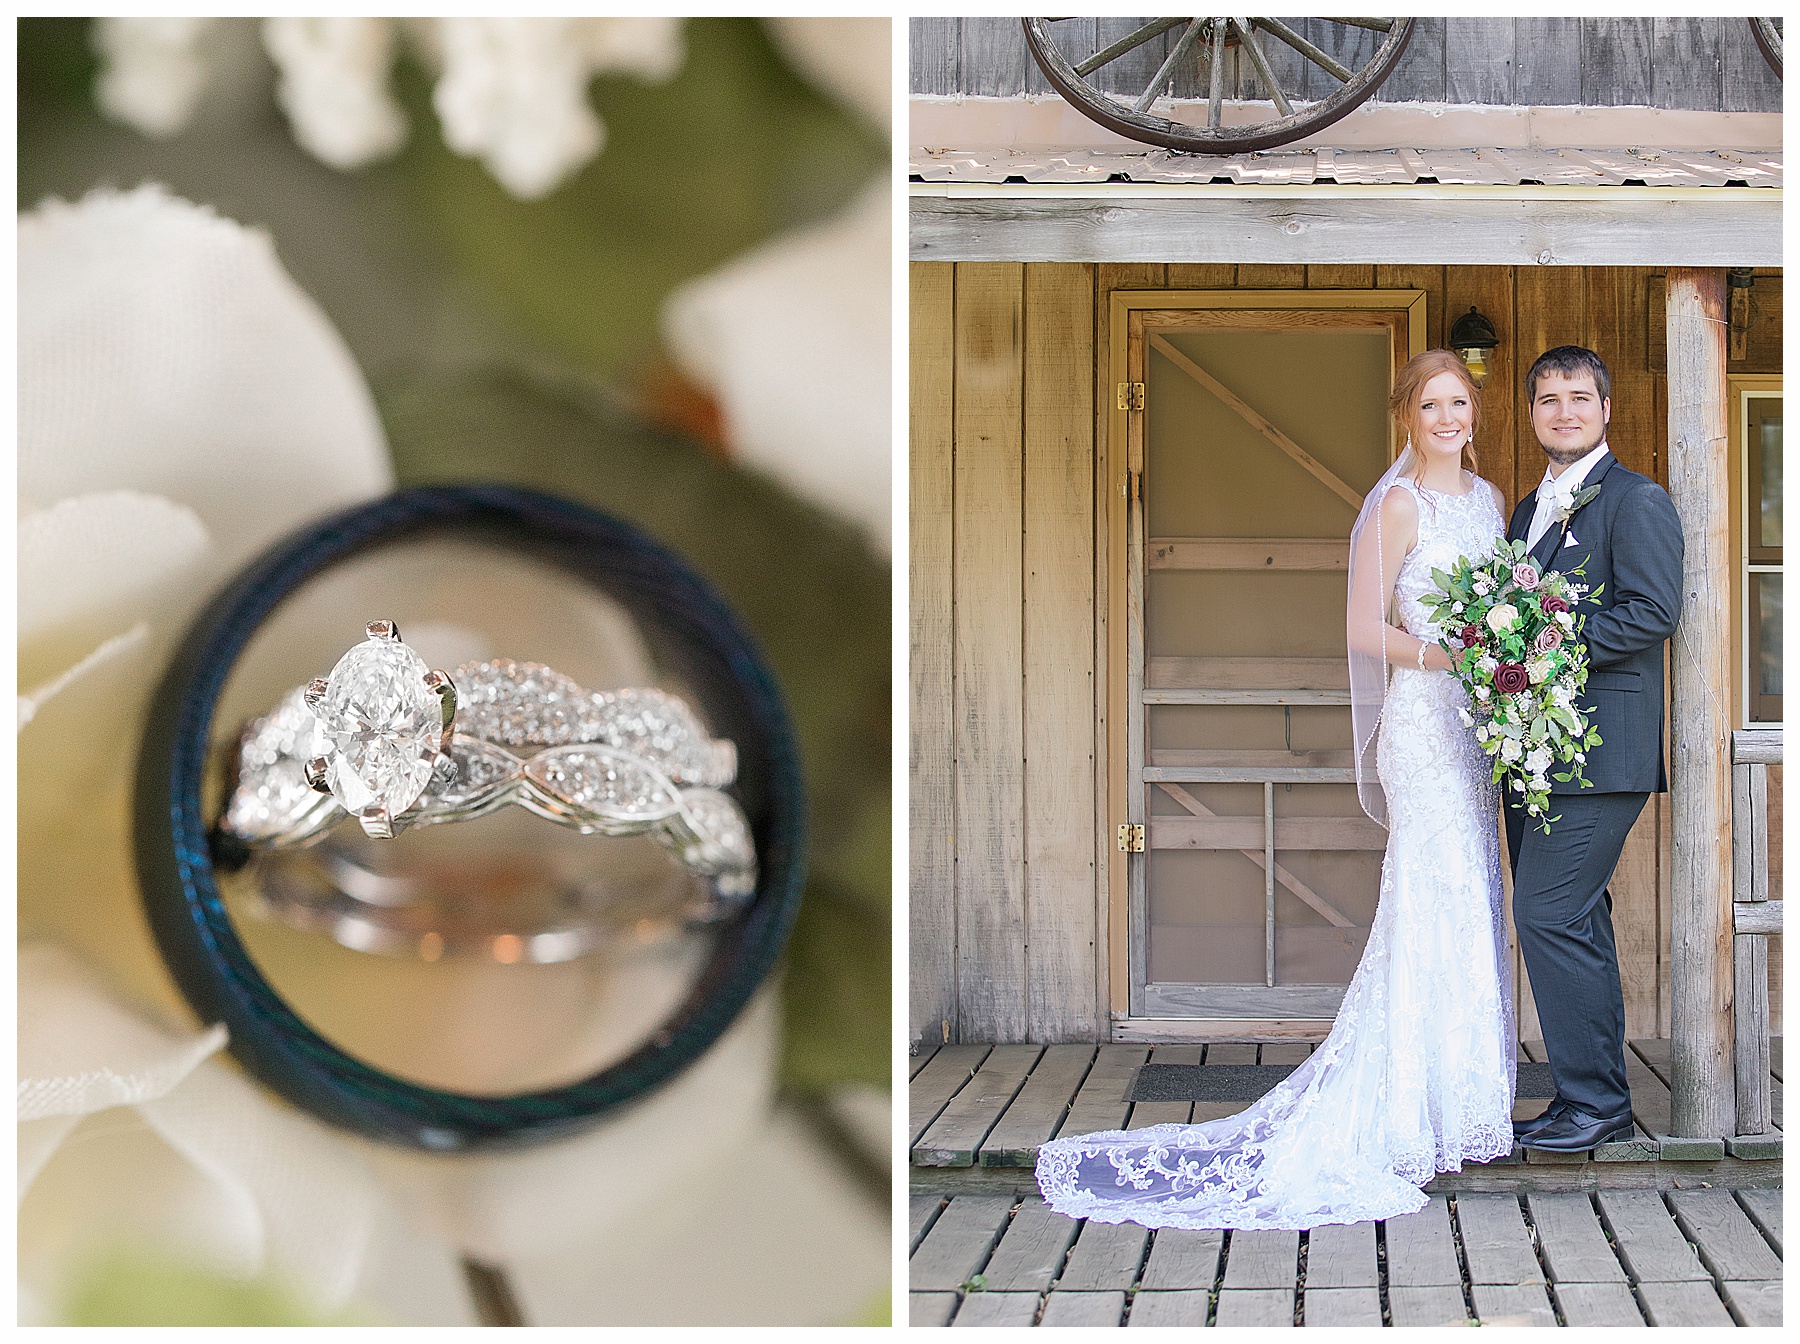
[909,1187,1782,1326]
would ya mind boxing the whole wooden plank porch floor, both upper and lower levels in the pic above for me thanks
[909,1040,1782,1326]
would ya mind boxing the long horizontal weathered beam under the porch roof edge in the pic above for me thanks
[907,184,1782,266]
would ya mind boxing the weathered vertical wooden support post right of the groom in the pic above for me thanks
[1667,266,1737,1139]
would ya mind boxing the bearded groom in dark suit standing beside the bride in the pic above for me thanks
[1507,345,1681,1153]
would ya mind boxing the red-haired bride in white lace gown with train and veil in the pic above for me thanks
[1037,351,1514,1229]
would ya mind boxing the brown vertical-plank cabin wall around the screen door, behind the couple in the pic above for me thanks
[911,263,1782,1042]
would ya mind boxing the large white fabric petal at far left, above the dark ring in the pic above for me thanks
[18,185,392,561]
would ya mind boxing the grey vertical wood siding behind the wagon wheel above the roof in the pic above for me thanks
[911,16,1782,112]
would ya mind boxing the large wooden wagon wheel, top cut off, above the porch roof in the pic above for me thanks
[1021,18,1413,155]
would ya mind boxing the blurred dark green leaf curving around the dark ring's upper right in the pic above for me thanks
[374,371,891,1096]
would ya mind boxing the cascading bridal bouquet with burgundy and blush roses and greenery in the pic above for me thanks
[1420,542,1600,833]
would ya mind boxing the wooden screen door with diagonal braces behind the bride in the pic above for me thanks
[1114,291,1424,1036]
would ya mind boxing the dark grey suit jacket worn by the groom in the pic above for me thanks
[1507,453,1681,793]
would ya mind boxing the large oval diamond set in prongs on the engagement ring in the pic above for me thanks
[313,637,443,817]
